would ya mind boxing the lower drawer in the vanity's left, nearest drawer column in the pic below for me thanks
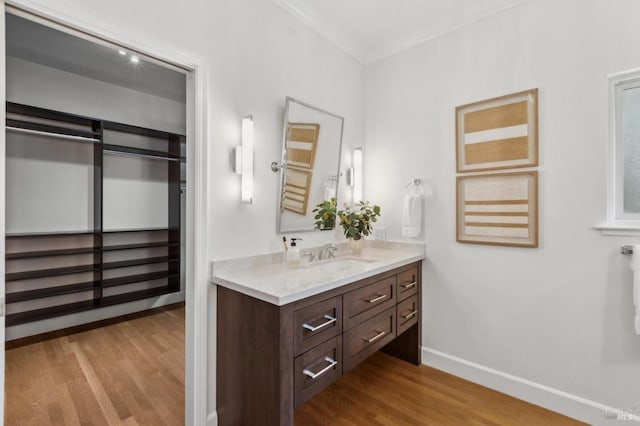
[293,336,342,407]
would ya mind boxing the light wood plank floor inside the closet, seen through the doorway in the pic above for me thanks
[5,307,185,426]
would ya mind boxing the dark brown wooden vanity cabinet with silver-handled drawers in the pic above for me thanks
[217,262,422,426]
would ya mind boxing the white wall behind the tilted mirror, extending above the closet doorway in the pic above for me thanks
[7,0,363,420]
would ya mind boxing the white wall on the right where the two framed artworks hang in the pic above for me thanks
[365,0,640,424]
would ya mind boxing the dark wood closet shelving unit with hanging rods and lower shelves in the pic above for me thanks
[5,102,185,326]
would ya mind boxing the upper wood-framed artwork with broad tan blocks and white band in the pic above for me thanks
[456,89,538,173]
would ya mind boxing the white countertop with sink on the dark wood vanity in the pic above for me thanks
[212,241,425,306]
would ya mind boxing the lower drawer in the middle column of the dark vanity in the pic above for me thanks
[343,306,396,373]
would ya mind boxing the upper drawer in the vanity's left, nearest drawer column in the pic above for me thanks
[293,296,342,355]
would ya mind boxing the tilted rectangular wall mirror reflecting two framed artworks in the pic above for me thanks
[278,97,344,233]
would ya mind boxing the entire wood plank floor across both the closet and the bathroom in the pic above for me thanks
[5,308,582,426]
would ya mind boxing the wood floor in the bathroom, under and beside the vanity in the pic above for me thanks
[295,352,584,426]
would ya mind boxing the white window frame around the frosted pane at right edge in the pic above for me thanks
[603,68,640,230]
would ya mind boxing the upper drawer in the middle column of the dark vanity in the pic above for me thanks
[344,275,396,330]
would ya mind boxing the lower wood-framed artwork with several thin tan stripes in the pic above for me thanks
[456,171,538,248]
